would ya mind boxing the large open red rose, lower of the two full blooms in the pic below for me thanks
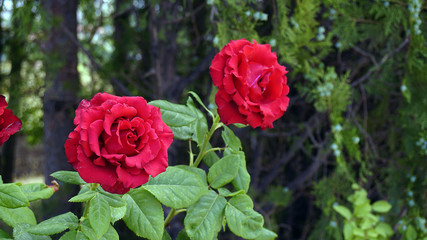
[65,93,173,194]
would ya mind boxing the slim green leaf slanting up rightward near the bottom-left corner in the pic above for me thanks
[27,212,79,235]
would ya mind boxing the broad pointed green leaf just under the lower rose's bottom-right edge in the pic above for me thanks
[142,167,208,209]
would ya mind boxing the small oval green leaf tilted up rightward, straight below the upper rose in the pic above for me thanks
[208,154,242,189]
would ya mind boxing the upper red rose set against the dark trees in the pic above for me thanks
[209,39,289,129]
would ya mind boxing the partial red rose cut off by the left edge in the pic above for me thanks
[0,95,22,146]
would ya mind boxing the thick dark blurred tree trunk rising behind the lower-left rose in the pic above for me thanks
[42,0,79,217]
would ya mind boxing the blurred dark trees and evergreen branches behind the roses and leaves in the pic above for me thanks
[0,0,427,239]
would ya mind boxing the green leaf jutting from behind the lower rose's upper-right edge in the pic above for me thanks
[148,100,197,140]
